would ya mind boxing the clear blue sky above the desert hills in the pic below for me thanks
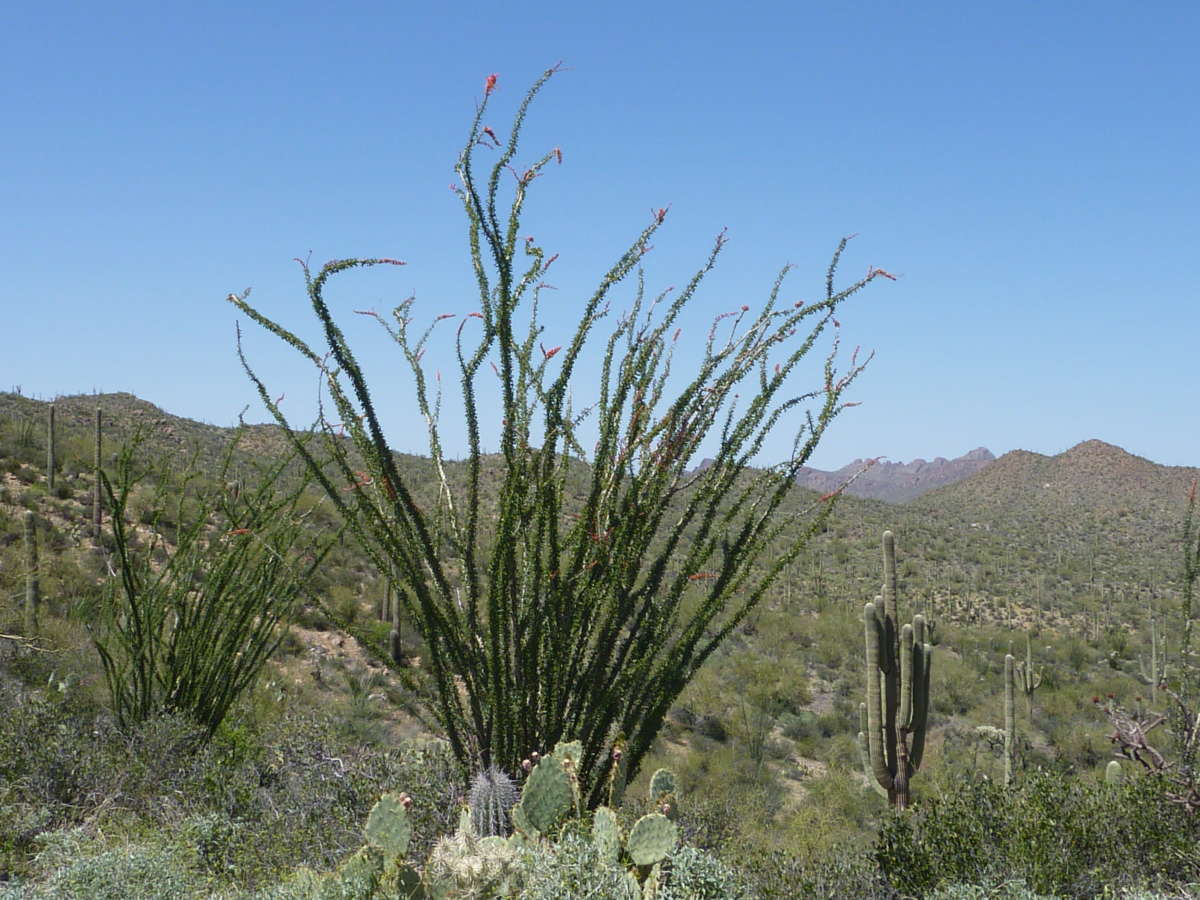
[0,0,1200,468]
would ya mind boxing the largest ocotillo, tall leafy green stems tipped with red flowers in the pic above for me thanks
[229,68,892,805]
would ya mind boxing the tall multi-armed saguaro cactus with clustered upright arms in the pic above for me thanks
[858,532,934,809]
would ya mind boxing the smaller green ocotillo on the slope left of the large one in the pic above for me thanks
[92,440,330,734]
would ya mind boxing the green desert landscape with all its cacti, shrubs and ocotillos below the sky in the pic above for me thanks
[0,70,1200,898]
